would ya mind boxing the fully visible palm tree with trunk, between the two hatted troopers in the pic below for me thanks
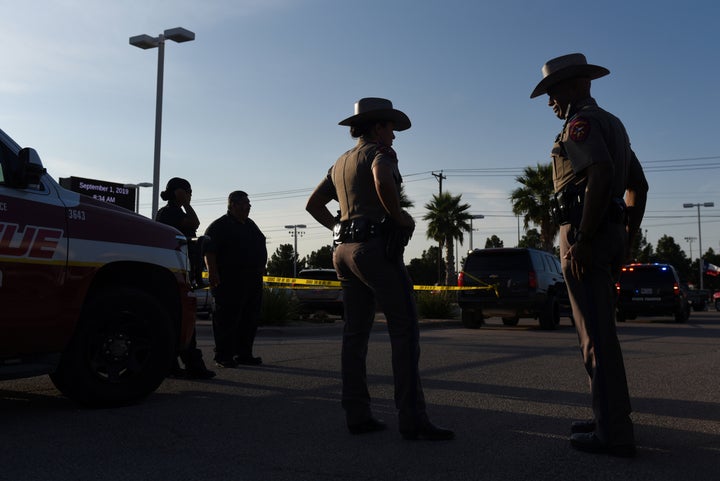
[423,192,472,285]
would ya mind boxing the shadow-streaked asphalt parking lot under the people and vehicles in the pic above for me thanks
[0,311,720,481]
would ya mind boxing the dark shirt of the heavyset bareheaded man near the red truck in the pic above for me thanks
[203,214,267,283]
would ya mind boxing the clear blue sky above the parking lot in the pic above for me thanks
[0,0,720,266]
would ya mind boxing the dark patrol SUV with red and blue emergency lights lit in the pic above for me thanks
[615,264,690,322]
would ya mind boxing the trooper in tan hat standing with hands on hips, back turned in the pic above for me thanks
[306,98,454,440]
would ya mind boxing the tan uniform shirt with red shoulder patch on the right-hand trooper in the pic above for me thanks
[552,97,640,198]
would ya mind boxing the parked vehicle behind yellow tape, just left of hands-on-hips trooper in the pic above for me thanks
[294,269,344,318]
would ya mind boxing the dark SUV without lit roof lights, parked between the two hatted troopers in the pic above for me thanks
[458,248,570,329]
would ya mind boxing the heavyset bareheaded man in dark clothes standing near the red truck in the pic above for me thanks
[203,190,267,367]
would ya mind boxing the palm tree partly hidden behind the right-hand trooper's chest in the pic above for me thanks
[510,163,559,252]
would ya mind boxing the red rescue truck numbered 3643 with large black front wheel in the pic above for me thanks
[0,130,195,406]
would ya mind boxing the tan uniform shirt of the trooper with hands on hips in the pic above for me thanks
[318,139,402,222]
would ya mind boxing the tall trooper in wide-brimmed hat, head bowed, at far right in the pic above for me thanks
[530,53,648,457]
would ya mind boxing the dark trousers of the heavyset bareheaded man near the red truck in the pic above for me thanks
[212,273,263,361]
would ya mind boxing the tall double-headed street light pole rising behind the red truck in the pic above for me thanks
[130,27,195,219]
